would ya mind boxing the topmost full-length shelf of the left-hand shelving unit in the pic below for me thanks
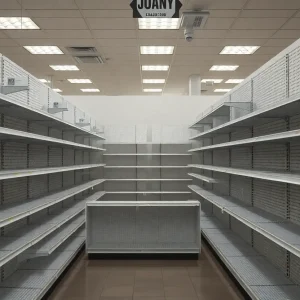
[0,94,105,140]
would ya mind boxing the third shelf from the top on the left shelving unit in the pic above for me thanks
[0,164,105,180]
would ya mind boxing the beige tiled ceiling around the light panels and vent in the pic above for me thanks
[0,0,300,95]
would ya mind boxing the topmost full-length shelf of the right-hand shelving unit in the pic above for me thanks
[191,97,300,140]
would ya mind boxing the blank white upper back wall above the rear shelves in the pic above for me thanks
[65,96,221,126]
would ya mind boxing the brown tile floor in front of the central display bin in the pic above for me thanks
[48,246,244,300]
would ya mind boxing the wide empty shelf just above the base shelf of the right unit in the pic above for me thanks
[189,186,300,257]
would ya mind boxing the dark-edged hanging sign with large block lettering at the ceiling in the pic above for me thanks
[130,0,182,18]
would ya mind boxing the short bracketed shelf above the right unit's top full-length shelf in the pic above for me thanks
[190,102,251,127]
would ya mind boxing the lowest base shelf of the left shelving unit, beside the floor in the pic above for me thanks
[0,236,84,300]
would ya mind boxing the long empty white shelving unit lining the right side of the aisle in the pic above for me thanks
[189,41,300,300]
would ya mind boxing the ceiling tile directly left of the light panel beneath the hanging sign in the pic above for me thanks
[86,18,137,30]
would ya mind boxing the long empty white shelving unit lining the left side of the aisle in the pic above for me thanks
[0,56,105,300]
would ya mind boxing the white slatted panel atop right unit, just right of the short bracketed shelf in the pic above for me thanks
[253,57,286,110]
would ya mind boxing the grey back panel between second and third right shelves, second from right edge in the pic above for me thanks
[253,144,287,171]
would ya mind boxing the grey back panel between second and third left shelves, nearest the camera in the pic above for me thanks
[3,142,28,170]
